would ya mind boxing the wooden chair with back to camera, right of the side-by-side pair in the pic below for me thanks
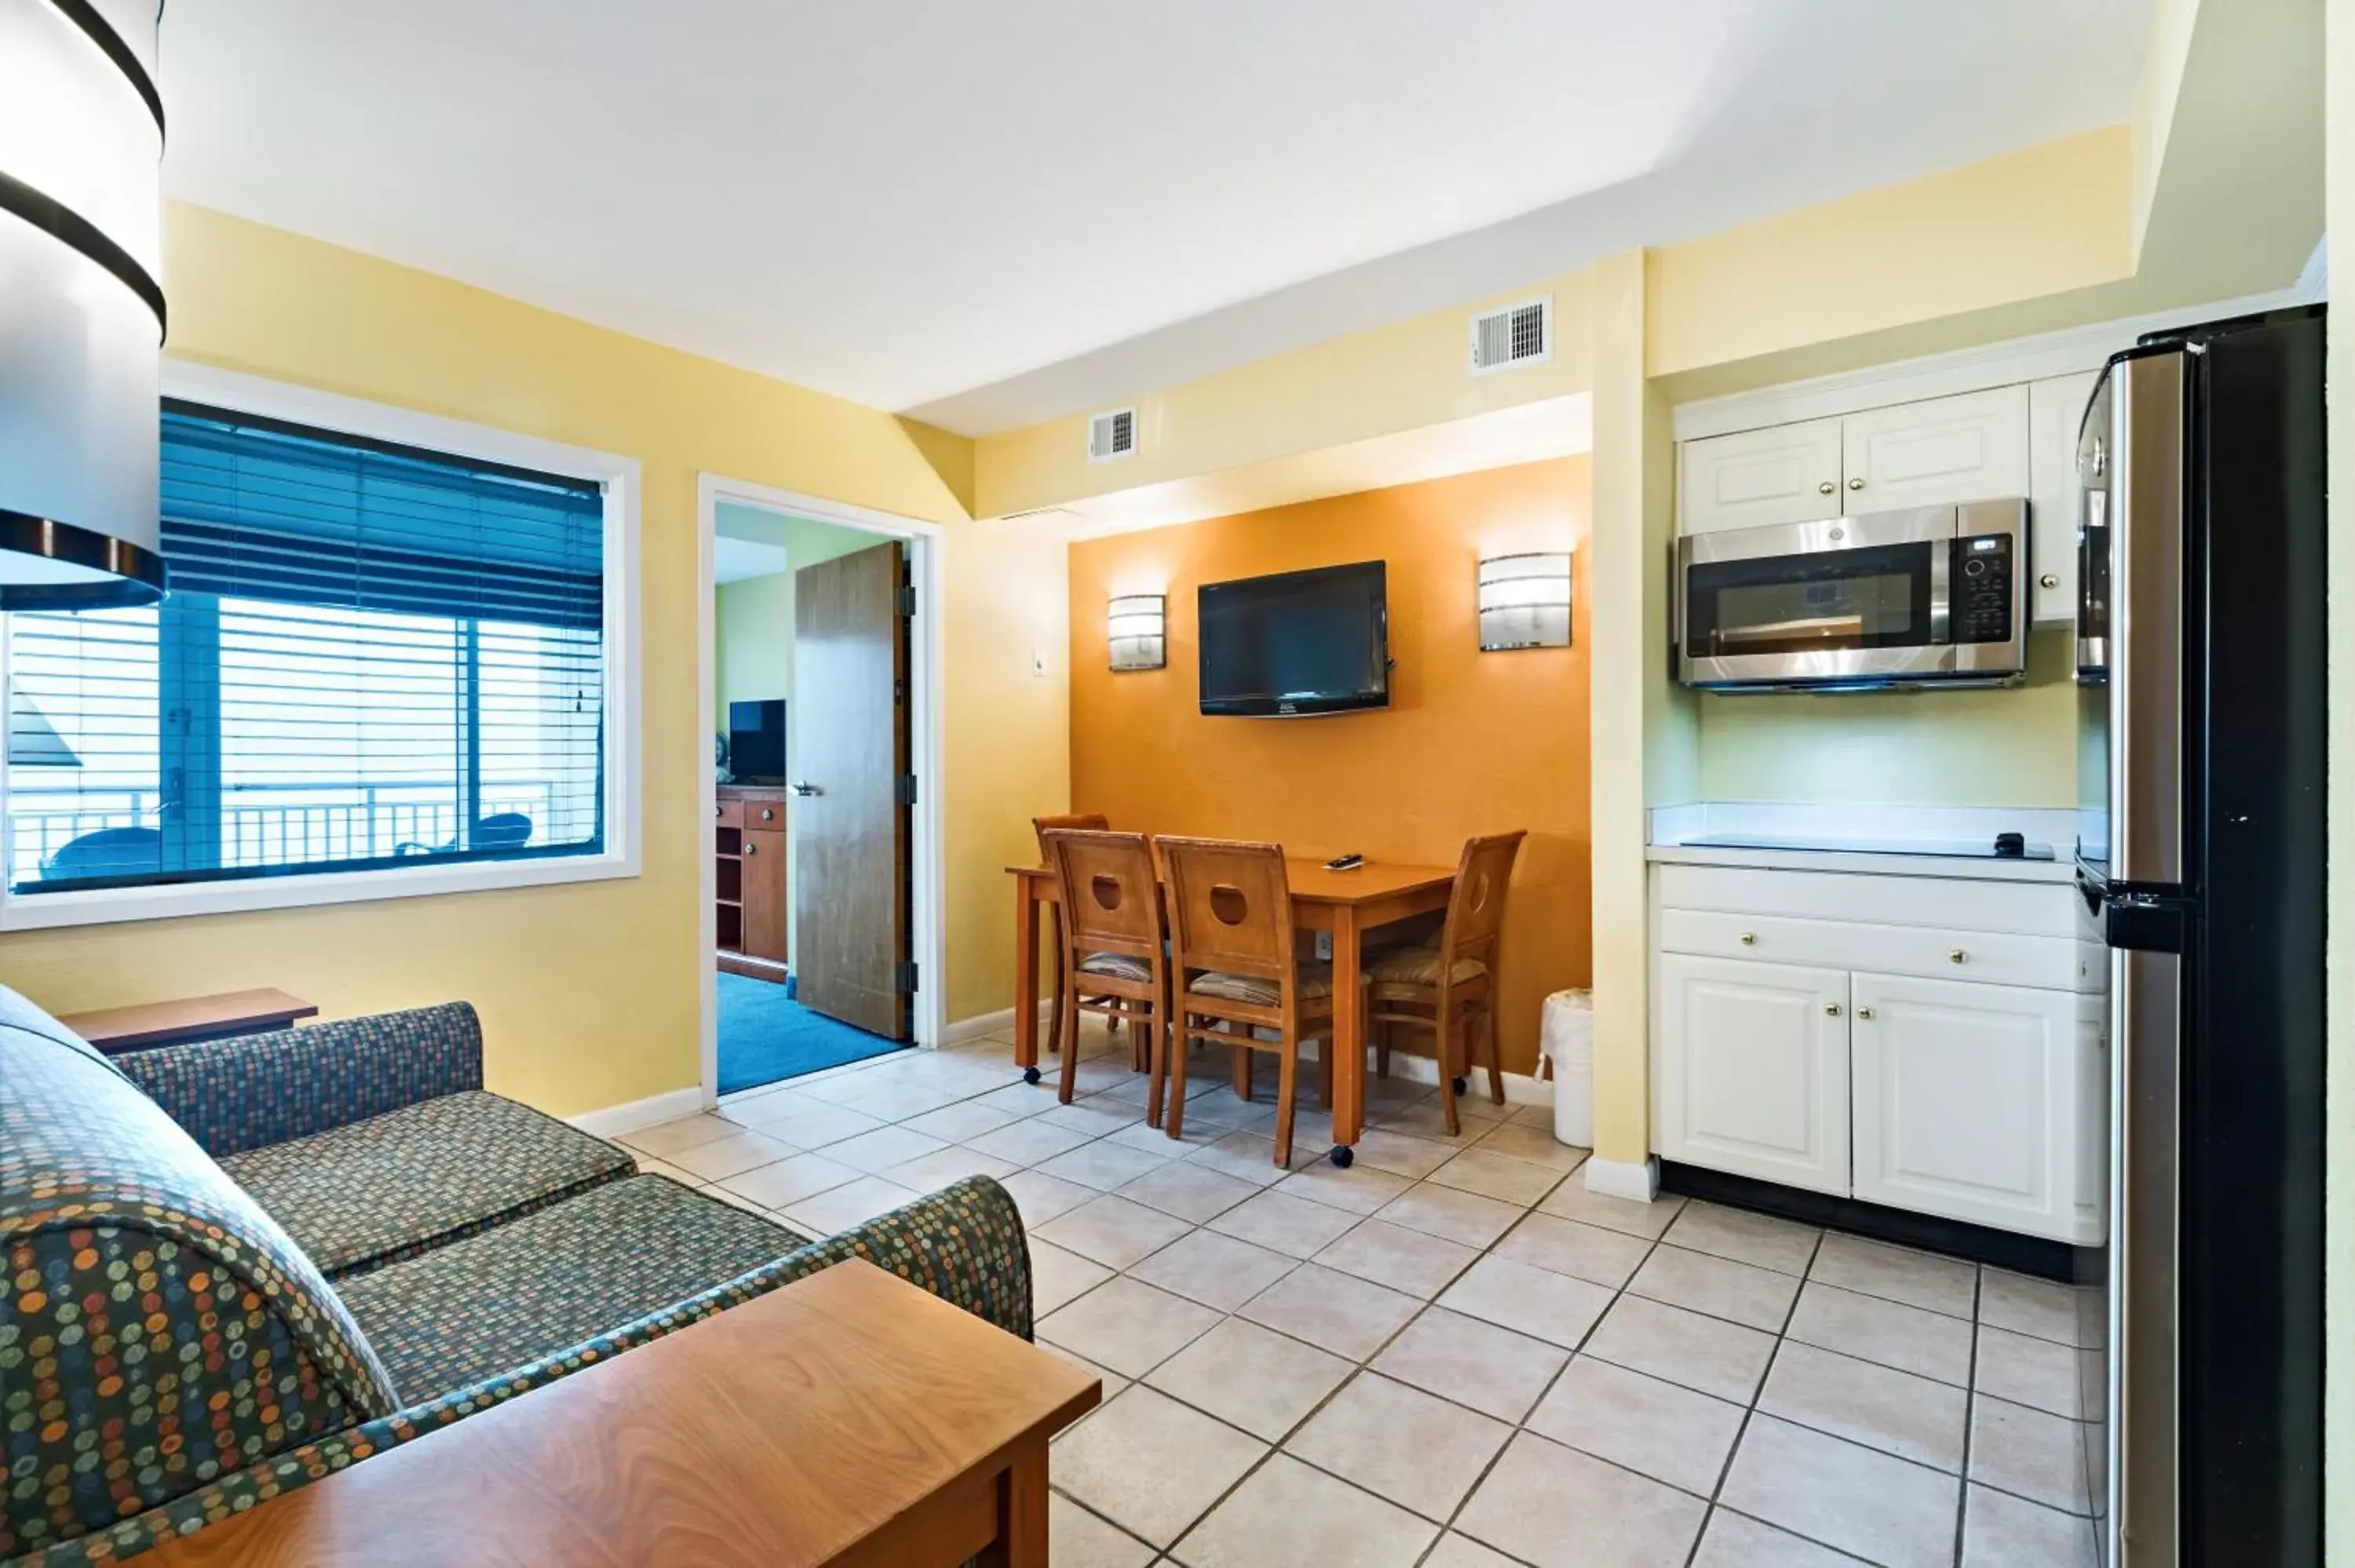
[1154,838,1333,1168]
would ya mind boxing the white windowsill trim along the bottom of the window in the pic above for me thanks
[0,852,638,932]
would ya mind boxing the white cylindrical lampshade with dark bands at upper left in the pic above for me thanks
[0,0,165,610]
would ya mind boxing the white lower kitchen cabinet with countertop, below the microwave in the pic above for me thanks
[1653,866,2110,1245]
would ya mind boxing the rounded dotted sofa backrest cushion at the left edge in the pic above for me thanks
[0,994,396,1556]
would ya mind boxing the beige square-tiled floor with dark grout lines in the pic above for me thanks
[624,1029,2094,1568]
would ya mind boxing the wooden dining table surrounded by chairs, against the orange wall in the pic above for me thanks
[1006,857,1455,1165]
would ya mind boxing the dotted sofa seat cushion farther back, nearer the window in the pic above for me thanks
[221,1090,636,1278]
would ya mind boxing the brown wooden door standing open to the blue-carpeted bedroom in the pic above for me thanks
[787,542,914,1041]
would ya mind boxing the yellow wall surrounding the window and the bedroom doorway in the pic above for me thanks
[0,205,1064,1114]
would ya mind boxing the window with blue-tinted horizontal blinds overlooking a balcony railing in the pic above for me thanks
[0,403,612,911]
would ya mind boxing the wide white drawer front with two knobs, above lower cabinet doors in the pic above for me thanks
[1660,909,2094,991]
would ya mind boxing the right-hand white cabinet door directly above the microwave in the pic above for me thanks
[1839,386,2028,513]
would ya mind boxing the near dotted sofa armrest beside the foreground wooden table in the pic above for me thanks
[21,1172,1031,1568]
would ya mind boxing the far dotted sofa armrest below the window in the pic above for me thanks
[115,1003,483,1158]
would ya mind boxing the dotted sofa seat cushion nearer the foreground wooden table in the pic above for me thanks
[341,1175,808,1403]
